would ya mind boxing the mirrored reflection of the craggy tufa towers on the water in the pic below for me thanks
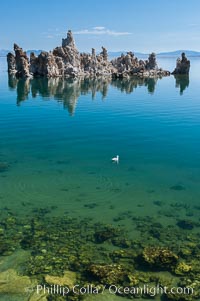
[8,75,189,115]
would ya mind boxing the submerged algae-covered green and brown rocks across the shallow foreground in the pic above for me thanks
[0,209,200,301]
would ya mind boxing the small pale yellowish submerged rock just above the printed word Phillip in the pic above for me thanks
[45,271,76,288]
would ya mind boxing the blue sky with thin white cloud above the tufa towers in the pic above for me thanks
[0,0,200,53]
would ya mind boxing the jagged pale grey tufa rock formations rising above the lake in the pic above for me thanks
[7,30,189,78]
